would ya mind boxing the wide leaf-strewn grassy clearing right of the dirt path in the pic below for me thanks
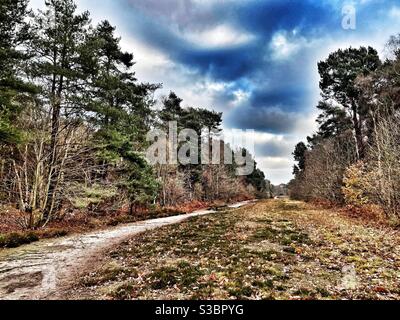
[63,200,400,299]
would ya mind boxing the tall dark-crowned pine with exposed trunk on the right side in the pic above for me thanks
[318,47,381,158]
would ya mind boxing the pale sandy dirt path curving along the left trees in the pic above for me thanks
[0,202,253,300]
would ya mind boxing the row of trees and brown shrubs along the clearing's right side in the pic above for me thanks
[290,35,400,219]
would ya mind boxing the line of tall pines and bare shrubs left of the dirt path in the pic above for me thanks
[0,0,270,227]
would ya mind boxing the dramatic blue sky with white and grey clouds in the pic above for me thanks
[31,0,400,184]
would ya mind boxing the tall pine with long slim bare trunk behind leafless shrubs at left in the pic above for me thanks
[31,0,90,220]
